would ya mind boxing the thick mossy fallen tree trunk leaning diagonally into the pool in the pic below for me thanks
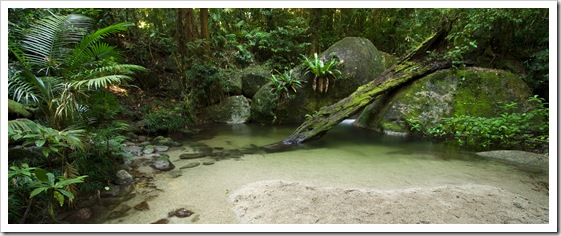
[276,19,451,150]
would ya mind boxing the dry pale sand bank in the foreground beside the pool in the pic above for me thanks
[230,180,549,224]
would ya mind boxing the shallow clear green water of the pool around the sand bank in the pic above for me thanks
[99,121,548,224]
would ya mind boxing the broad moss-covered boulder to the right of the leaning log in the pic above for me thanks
[354,68,531,134]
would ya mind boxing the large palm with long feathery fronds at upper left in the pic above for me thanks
[8,12,144,128]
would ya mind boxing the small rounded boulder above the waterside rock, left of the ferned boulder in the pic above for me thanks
[241,66,271,98]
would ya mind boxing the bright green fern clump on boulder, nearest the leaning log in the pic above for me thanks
[302,53,341,93]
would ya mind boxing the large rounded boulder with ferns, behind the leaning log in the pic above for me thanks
[251,37,385,124]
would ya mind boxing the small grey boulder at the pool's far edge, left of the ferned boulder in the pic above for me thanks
[204,96,251,124]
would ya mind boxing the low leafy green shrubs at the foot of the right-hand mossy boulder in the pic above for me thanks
[408,96,549,152]
